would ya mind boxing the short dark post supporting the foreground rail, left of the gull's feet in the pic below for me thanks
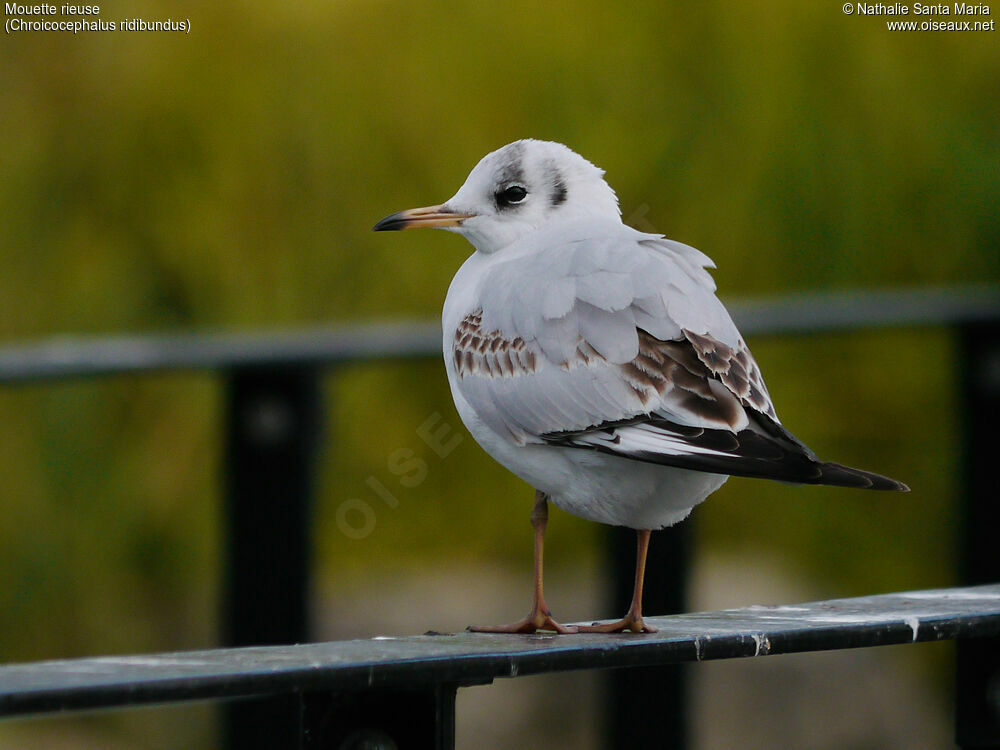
[301,685,456,750]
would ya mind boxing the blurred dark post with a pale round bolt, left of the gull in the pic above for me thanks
[223,366,321,750]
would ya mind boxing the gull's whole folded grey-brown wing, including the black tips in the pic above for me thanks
[449,225,905,489]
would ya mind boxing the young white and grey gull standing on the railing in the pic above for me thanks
[375,140,907,633]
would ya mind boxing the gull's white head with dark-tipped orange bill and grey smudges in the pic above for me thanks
[375,140,621,253]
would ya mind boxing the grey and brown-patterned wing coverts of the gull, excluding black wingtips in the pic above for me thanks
[450,225,773,443]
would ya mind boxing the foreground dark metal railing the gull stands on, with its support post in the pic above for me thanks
[0,584,1000,748]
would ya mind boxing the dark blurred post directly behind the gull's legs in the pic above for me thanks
[604,521,692,750]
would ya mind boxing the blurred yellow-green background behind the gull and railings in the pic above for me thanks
[0,0,1000,747]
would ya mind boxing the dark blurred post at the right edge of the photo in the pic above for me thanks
[955,321,1000,748]
